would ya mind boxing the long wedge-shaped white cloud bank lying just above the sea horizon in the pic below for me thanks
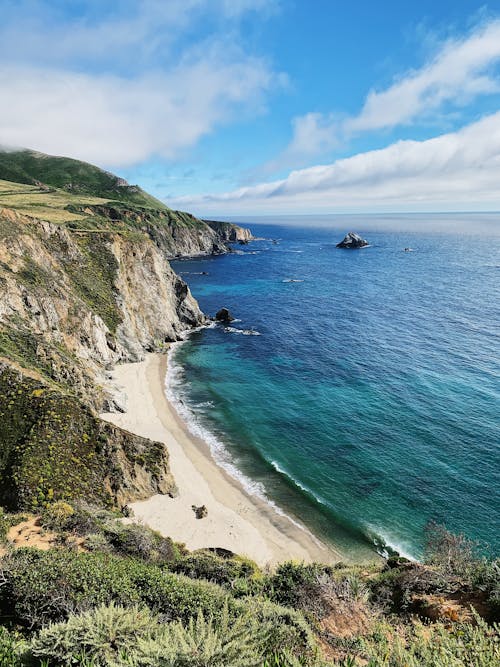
[167,112,500,215]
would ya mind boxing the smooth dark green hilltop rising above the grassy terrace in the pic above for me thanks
[0,150,167,209]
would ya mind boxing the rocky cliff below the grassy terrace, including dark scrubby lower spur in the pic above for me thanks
[0,209,204,508]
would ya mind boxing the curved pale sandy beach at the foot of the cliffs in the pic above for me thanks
[101,354,341,566]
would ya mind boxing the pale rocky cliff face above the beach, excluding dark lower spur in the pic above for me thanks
[0,209,204,407]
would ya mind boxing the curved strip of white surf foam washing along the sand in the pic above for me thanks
[165,340,317,541]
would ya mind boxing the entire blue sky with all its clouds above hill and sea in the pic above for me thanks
[0,0,500,217]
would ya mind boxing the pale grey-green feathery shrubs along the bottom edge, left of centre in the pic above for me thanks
[25,605,267,667]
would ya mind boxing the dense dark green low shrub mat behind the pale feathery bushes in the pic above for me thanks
[0,548,237,628]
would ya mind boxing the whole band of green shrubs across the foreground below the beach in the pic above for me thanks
[0,502,500,667]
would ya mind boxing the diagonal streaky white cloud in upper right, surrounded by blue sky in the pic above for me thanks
[276,20,500,172]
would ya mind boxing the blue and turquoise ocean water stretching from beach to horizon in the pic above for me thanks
[172,225,500,557]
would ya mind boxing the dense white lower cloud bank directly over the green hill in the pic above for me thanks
[0,54,275,166]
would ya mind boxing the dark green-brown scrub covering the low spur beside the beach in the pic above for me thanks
[0,364,172,509]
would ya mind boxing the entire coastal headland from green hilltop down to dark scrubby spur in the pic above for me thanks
[0,152,250,507]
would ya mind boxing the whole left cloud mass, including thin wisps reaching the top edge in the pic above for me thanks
[0,0,283,168]
